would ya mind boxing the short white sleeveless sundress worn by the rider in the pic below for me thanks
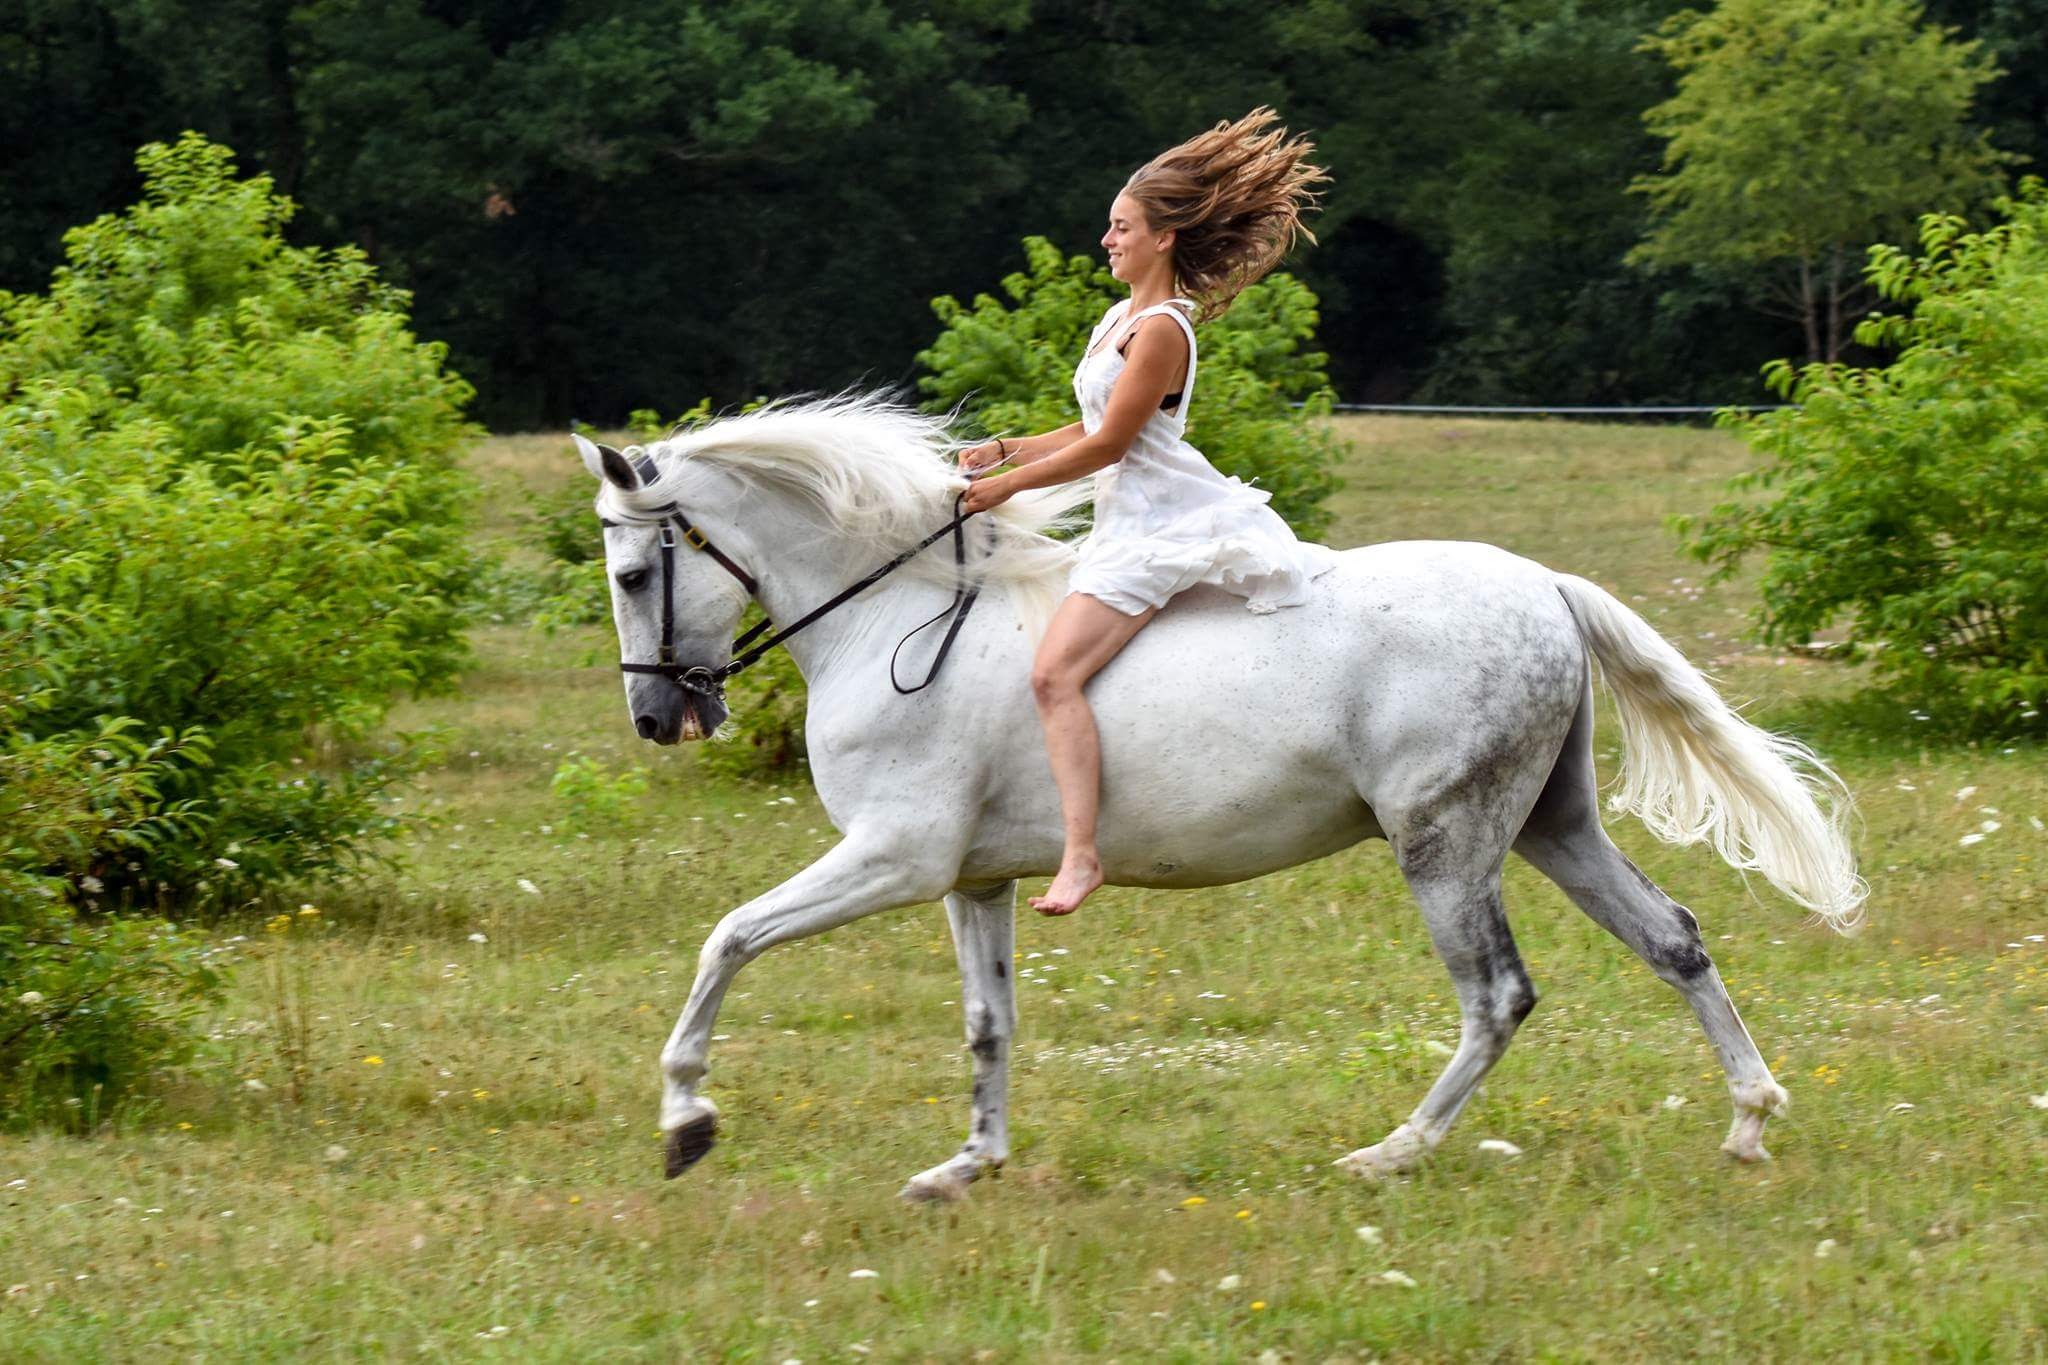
[1067,299,1337,616]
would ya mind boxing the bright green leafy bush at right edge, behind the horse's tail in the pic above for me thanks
[1692,180,2048,731]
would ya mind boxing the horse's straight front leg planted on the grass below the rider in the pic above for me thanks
[903,882,1018,1199]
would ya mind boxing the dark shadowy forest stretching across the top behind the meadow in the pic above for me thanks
[0,0,2048,430]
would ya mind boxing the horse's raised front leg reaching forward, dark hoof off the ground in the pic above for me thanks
[662,835,954,1179]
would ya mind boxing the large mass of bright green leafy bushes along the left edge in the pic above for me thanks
[0,137,471,1105]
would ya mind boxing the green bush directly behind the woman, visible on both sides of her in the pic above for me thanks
[918,237,1339,536]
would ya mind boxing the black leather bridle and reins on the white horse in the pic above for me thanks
[602,454,993,704]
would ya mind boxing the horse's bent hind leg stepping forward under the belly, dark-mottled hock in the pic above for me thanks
[1337,834,1536,1175]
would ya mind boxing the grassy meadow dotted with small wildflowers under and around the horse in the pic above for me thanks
[0,420,2048,1363]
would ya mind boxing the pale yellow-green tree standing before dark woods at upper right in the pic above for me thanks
[1628,0,2011,360]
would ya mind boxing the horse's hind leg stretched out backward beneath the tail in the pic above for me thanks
[1516,694,1786,1160]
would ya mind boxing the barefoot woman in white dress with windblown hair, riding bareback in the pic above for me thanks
[961,108,1335,915]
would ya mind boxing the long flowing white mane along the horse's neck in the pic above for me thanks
[598,393,1094,641]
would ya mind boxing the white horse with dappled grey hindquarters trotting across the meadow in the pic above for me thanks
[578,397,1866,1199]
